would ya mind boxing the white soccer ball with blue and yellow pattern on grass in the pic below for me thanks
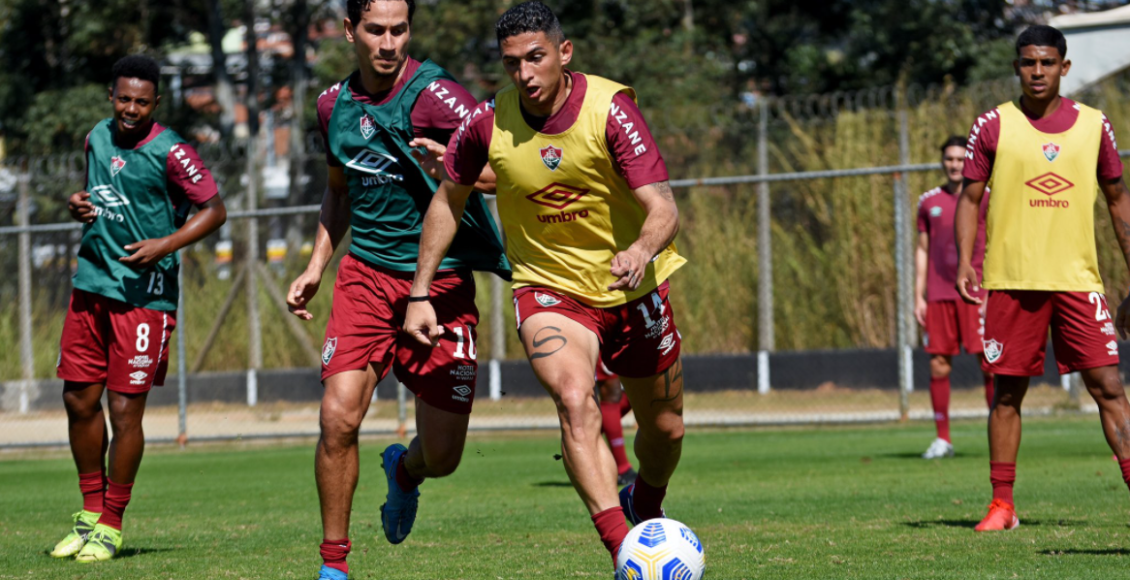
[616,518,706,580]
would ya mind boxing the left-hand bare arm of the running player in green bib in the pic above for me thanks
[286,166,349,320]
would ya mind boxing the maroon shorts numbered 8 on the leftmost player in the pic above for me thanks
[55,288,176,393]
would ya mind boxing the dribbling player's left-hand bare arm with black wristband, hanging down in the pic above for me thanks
[405,180,475,346]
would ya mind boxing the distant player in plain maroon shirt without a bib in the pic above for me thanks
[914,136,992,459]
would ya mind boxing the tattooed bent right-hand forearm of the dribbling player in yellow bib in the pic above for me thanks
[608,181,679,291]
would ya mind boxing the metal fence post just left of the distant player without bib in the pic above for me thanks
[894,98,914,421]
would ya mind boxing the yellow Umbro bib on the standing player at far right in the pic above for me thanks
[983,103,1103,292]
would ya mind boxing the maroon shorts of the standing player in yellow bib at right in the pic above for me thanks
[983,291,1119,376]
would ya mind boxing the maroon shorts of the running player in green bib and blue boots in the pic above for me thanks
[322,254,479,415]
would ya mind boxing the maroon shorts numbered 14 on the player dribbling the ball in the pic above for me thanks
[514,282,683,379]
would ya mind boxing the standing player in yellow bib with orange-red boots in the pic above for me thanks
[956,26,1130,531]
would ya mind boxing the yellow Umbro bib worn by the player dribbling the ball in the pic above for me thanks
[489,75,686,308]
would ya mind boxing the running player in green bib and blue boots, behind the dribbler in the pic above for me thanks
[287,0,510,580]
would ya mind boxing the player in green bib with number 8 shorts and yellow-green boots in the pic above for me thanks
[51,55,227,562]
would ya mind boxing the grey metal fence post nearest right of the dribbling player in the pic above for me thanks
[757,96,775,395]
